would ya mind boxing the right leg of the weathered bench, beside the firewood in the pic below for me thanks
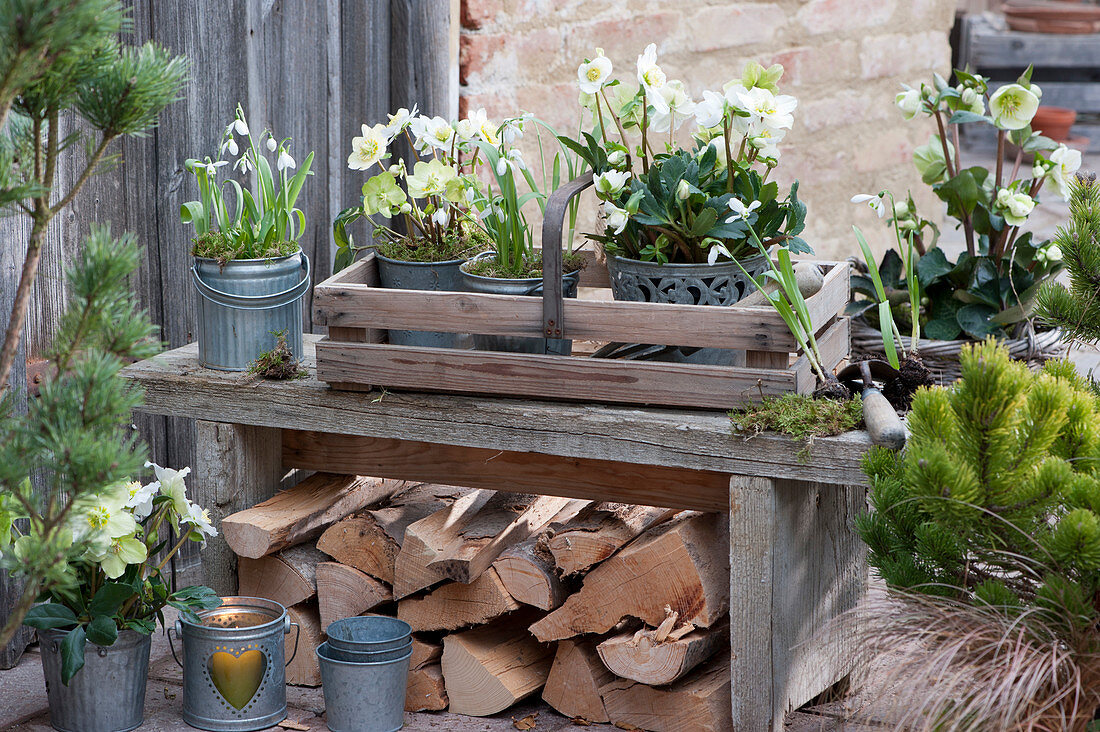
[729,477,867,732]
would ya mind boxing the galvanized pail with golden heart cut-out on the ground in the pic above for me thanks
[168,597,298,732]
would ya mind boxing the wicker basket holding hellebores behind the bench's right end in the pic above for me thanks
[851,318,1066,386]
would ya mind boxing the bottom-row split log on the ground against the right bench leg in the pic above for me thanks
[600,653,734,732]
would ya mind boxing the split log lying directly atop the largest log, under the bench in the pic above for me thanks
[549,503,679,575]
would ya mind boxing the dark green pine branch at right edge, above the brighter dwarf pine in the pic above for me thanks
[1036,177,1100,343]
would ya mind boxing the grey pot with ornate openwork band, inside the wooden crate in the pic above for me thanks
[607,253,768,365]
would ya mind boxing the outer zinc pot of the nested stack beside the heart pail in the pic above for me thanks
[317,643,413,732]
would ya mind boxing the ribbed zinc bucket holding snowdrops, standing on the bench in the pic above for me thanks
[191,250,310,371]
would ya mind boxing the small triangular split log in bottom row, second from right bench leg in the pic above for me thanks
[542,640,615,722]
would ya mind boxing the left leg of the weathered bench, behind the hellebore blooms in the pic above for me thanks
[191,419,283,597]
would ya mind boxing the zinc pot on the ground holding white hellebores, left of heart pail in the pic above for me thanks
[39,630,150,732]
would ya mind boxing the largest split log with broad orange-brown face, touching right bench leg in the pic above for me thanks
[530,511,729,642]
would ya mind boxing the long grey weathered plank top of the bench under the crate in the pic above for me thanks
[123,337,870,484]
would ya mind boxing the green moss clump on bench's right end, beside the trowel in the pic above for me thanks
[729,394,864,462]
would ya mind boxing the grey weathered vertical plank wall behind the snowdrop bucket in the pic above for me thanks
[0,0,458,662]
